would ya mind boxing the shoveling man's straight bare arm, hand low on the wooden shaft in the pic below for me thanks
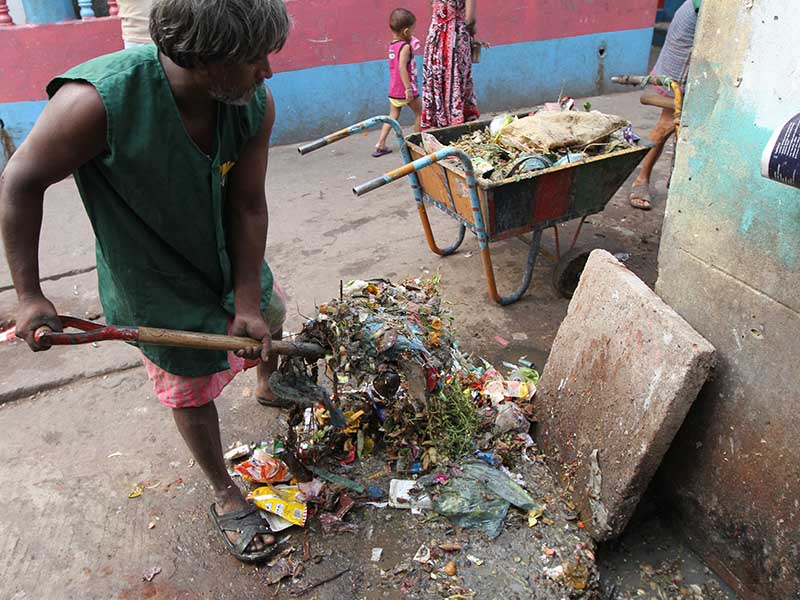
[227,89,275,360]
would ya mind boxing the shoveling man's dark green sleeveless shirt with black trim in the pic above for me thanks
[47,45,272,377]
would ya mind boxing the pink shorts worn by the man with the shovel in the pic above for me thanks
[142,283,286,408]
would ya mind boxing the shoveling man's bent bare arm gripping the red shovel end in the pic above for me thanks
[0,83,106,350]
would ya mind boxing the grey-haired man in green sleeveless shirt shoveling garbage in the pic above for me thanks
[0,0,289,562]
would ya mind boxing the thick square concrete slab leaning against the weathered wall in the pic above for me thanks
[536,250,715,541]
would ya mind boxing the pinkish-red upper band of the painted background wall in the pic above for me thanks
[0,0,656,102]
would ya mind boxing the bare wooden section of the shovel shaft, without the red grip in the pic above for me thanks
[138,327,325,359]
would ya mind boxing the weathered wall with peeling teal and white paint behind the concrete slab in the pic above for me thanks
[656,0,800,599]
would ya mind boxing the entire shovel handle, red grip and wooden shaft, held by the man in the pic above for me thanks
[34,316,325,360]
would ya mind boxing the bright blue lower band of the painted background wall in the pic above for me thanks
[0,28,653,156]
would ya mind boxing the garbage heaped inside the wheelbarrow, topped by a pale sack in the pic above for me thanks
[422,97,639,181]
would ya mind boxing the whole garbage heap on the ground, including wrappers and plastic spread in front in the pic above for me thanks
[220,278,596,591]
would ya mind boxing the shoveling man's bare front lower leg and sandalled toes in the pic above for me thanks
[172,402,275,553]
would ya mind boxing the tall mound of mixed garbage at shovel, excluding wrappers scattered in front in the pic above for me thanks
[271,279,539,475]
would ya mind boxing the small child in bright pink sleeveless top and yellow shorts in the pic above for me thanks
[372,8,422,158]
